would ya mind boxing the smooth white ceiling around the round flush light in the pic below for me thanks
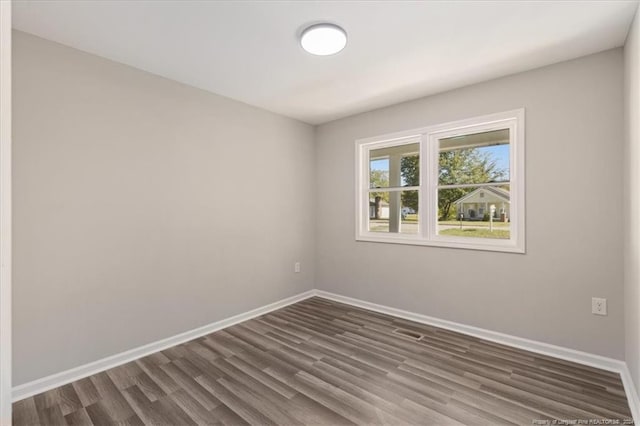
[13,0,637,124]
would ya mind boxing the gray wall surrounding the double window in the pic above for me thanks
[316,49,624,359]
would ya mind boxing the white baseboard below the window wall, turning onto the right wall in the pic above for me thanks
[315,290,640,425]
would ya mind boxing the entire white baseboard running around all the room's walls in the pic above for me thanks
[13,290,640,425]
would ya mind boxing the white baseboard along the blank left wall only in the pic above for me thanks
[12,290,316,402]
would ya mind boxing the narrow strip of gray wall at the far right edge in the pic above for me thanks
[624,5,640,394]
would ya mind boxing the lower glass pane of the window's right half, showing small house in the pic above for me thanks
[438,185,511,240]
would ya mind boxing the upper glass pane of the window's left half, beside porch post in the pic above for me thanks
[369,143,420,188]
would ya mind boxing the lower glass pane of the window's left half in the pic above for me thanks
[369,191,418,234]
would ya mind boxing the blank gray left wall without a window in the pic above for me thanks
[13,32,315,385]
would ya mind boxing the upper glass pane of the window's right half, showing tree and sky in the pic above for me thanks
[438,129,510,185]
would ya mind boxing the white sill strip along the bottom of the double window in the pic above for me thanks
[356,235,526,254]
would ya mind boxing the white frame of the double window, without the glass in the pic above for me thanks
[355,108,526,253]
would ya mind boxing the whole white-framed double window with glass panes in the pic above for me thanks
[356,110,525,253]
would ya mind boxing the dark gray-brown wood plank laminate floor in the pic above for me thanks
[13,298,631,426]
